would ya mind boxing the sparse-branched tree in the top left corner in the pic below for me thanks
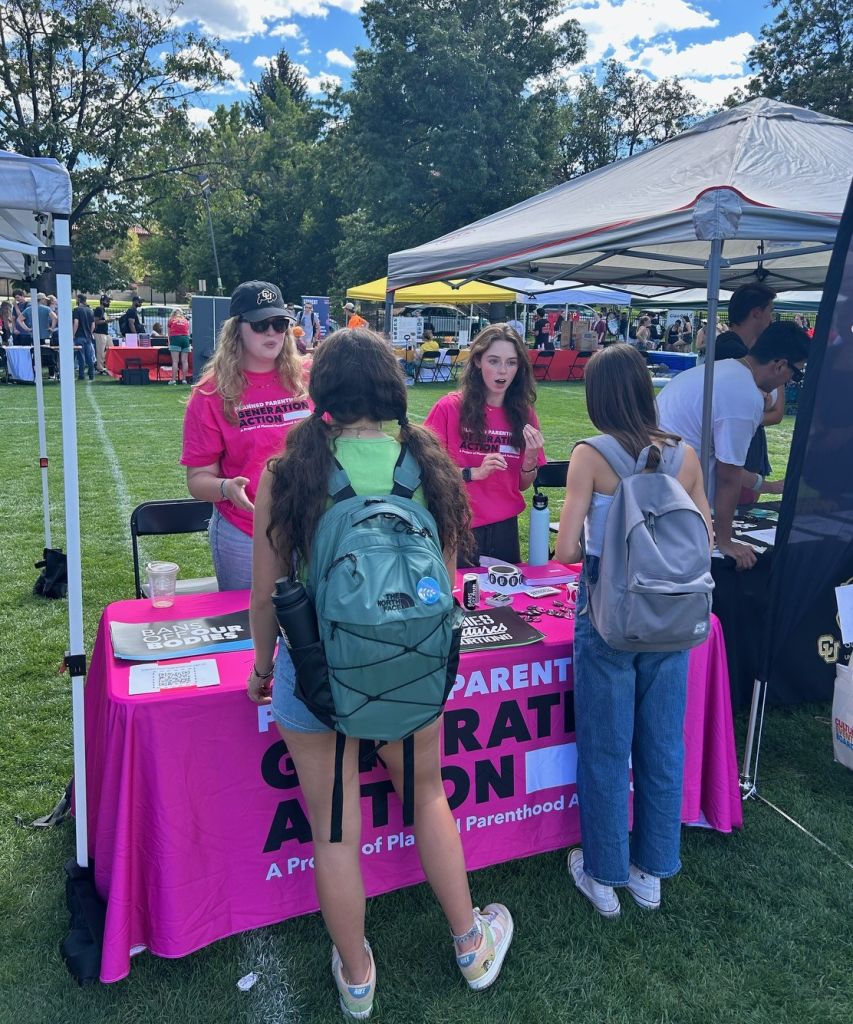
[0,0,223,282]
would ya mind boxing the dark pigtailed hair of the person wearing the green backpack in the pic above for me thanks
[266,328,472,565]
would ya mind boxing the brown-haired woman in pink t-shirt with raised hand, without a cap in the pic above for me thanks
[424,324,545,563]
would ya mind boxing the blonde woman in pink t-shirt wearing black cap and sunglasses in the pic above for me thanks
[180,281,313,590]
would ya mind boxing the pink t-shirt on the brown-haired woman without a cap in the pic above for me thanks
[424,391,546,526]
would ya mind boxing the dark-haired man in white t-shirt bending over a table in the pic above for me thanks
[657,323,809,569]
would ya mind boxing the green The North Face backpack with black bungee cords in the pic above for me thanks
[296,445,463,841]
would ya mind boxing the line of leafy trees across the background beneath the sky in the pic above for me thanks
[0,0,853,296]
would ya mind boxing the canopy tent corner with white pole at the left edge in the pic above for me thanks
[0,151,89,867]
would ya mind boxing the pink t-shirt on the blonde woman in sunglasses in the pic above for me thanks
[180,371,313,537]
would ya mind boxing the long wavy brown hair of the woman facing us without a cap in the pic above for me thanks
[459,324,537,451]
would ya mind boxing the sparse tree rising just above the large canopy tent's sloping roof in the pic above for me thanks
[556,60,700,180]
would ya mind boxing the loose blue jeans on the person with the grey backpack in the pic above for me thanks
[574,557,689,886]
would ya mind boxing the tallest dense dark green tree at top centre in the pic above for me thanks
[327,0,586,284]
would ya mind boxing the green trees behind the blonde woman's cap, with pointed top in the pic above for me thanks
[147,61,341,299]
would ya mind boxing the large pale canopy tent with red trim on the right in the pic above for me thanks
[388,99,853,475]
